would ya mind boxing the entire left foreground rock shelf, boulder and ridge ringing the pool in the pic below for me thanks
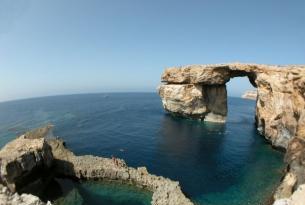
[0,126,193,205]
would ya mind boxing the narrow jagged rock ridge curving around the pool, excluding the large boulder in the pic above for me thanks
[48,139,193,205]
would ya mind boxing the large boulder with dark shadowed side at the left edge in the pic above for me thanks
[0,135,53,192]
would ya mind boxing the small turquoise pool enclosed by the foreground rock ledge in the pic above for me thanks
[49,180,152,205]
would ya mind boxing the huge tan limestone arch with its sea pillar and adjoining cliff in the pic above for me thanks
[159,63,305,149]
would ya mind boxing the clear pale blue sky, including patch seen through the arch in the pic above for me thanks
[0,0,305,101]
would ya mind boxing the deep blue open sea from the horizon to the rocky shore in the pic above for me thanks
[0,93,284,205]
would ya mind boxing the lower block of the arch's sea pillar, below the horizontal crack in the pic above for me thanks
[159,84,227,122]
